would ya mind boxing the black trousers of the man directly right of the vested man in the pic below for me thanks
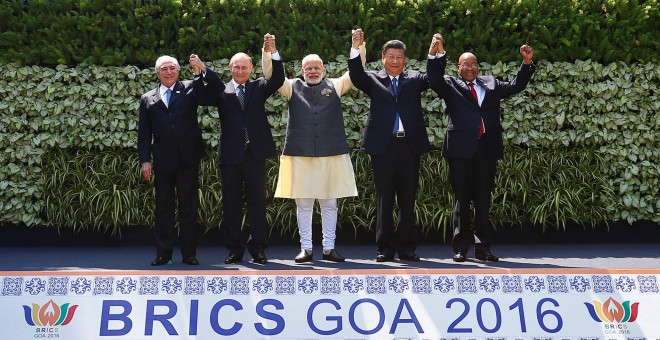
[371,137,419,255]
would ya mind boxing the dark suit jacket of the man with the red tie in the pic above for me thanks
[427,56,536,160]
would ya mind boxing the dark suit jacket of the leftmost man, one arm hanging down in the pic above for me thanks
[138,81,204,173]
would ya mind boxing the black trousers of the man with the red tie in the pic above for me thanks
[447,138,497,253]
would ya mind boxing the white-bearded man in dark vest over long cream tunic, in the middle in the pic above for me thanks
[264,33,364,263]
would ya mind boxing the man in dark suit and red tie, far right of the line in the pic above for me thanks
[428,34,536,262]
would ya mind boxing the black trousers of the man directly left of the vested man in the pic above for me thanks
[220,148,268,254]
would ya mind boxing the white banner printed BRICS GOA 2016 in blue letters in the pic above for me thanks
[0,269,660,340]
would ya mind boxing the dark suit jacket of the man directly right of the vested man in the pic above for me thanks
[348,58,431,155]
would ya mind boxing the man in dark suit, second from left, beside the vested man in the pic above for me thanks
[190,34,284,264]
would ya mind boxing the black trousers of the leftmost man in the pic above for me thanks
[154,161,199,258]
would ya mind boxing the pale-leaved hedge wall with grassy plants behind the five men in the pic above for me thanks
[0,57,660,233]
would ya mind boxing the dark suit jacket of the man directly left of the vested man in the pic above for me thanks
[194,60,284,164]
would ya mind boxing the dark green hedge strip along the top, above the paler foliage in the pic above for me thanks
[0,0,660,66]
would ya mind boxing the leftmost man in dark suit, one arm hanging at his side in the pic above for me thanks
[138,56,204,266]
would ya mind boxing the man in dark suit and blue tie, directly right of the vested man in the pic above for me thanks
[348,29,444,262]
